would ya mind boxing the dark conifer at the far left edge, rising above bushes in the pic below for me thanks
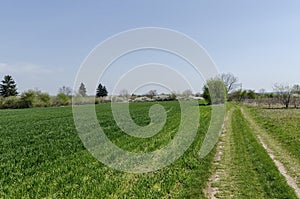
[0,75,18,97]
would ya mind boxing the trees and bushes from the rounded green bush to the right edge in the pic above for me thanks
[202,73,300,108]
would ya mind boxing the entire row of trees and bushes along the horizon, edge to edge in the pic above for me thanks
[0,73,300,108]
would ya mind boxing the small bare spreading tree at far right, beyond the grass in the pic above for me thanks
[273,83,292,108]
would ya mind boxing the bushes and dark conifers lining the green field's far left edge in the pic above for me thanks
[0,75,108,109]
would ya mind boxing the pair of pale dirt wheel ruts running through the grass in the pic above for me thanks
[204,106,300,199]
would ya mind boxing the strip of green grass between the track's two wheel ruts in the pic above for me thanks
[217,105,297,198]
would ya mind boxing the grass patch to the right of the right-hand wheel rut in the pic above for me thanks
[250,107,300,160]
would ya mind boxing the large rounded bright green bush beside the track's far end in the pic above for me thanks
[203,78,227,104]
